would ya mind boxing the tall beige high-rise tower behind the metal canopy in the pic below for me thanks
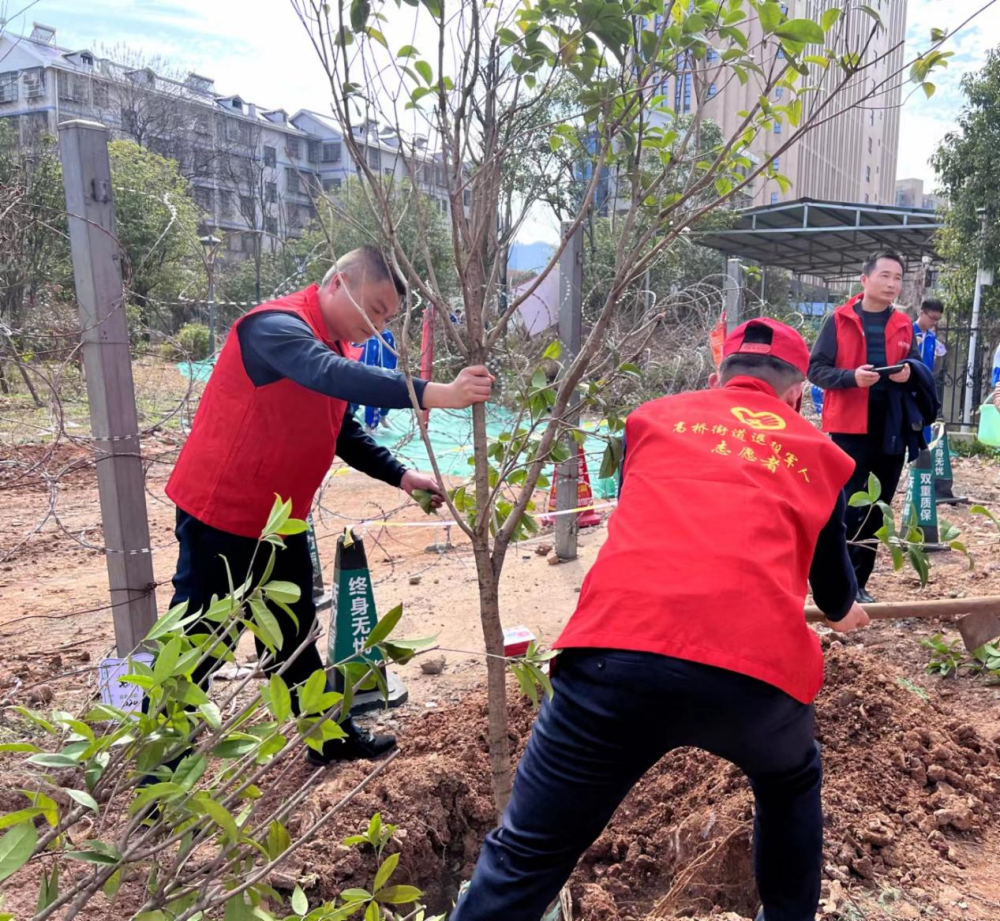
[657,0,906,205]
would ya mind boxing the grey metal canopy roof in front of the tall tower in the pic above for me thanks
[691,198,942,281]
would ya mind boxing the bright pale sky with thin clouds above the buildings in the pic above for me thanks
[0,0,1000,241]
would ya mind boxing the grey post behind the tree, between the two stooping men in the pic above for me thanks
[555,223,583,560]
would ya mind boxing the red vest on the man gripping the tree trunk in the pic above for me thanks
[166,285,354,537]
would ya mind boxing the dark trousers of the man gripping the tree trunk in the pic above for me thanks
[170,509,323,713]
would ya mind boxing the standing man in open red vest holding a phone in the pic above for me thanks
[809,253,938,604]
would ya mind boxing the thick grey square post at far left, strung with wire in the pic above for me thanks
[59,121,156,657]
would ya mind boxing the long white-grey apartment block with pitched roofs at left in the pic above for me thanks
[0,23,458,258]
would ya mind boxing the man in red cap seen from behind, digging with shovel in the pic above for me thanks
[452,320,868,921]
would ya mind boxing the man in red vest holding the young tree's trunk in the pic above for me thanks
[167,247,492,763]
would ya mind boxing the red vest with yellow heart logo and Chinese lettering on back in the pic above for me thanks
[555,377,854,703]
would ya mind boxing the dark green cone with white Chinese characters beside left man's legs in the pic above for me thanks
[327,529,381,665]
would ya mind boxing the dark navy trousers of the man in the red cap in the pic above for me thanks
[451,650,823,921]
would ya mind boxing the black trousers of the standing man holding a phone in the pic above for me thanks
[830,400,906,589]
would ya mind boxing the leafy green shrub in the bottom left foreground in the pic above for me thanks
[0,499,432,921]
